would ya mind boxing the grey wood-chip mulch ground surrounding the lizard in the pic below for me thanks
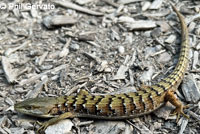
[0,0,200,134]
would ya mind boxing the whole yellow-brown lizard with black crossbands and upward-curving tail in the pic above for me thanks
[15,5,189,133]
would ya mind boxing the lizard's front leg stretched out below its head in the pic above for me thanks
[37,112,75,134]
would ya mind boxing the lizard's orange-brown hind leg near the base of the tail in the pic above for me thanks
[165,91,189,122]
